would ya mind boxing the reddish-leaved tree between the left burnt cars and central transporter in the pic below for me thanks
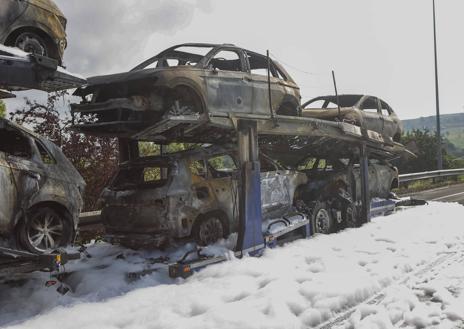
[10,92,118,210]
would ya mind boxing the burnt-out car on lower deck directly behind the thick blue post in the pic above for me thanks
[100,146,306,248]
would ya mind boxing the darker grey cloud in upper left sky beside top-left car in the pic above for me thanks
[56,0,212,75]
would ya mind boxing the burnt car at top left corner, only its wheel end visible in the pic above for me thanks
[0,0,67,64]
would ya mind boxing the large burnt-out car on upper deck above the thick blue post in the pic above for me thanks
[71,43,301,137]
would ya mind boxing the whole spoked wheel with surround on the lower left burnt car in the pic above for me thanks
[19,207,72,254]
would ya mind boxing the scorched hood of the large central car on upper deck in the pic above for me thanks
[74,69,160,96]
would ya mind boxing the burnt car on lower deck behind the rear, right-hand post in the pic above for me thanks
[296,157,399,233]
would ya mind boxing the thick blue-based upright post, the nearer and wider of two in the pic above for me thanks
[235,120,265,255]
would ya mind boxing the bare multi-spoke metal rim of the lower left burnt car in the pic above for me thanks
[26,213,64,251]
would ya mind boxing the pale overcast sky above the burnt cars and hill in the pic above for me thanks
[3,0,464,119]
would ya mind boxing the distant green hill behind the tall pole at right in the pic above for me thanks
[403,113,464,150]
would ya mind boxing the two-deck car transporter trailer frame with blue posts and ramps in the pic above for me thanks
[0,46,404,278]
